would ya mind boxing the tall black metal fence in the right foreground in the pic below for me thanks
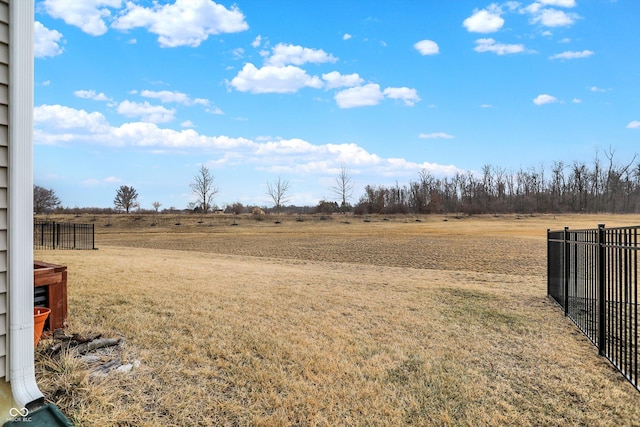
[547,224,640,391]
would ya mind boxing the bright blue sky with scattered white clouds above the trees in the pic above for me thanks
[34,0,640,209]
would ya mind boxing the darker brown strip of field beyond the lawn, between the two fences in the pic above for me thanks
[96,216,546,275]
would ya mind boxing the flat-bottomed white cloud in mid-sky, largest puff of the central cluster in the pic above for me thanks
[230,63,323,93]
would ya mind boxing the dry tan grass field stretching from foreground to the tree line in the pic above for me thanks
[35,215,640,426]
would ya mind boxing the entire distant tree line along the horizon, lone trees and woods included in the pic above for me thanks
[34,149,640,215]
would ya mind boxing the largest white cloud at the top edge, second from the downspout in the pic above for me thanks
[112,0,249,47]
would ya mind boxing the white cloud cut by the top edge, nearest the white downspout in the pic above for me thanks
[42,0,122,36]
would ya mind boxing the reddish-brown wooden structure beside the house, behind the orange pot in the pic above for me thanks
[33,261,67,331]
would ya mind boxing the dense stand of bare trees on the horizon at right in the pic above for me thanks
[354,150,640,215]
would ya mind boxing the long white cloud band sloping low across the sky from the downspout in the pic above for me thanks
[34,105,461,189]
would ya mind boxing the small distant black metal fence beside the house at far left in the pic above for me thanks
[33,220,96,249]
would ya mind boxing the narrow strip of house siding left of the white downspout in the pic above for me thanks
[0,0,9,379]
